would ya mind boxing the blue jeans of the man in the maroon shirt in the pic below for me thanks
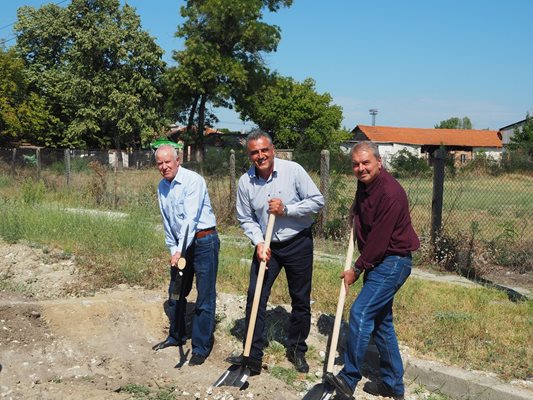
[339,256,412,395]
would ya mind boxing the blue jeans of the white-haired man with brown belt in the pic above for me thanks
[168,233,220,357]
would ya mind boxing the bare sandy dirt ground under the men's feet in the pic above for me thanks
[0,242,528,400]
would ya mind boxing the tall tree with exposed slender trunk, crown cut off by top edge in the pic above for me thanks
[172,0,292,159]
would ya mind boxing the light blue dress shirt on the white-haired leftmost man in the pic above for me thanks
[157,166,216,255]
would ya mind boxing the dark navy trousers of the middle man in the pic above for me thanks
[246,229,313,359]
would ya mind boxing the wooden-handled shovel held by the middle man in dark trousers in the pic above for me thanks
[213,214,276,388]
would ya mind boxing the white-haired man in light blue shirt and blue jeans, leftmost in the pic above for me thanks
[153,145,220,365]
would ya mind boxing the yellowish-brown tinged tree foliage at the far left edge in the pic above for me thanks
[0,49,54,145]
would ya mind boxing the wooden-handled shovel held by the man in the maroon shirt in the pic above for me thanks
[302,229,354,400]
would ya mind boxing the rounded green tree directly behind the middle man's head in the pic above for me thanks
[237,76,349,149]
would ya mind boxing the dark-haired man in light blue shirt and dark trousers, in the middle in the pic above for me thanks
[228,131,324,374]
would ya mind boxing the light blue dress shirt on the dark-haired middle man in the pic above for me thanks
[237,158,324,245]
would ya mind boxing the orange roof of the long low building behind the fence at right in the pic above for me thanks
[352,125,502,147]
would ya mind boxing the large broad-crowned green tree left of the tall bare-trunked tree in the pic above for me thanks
[15,0,165,149]
